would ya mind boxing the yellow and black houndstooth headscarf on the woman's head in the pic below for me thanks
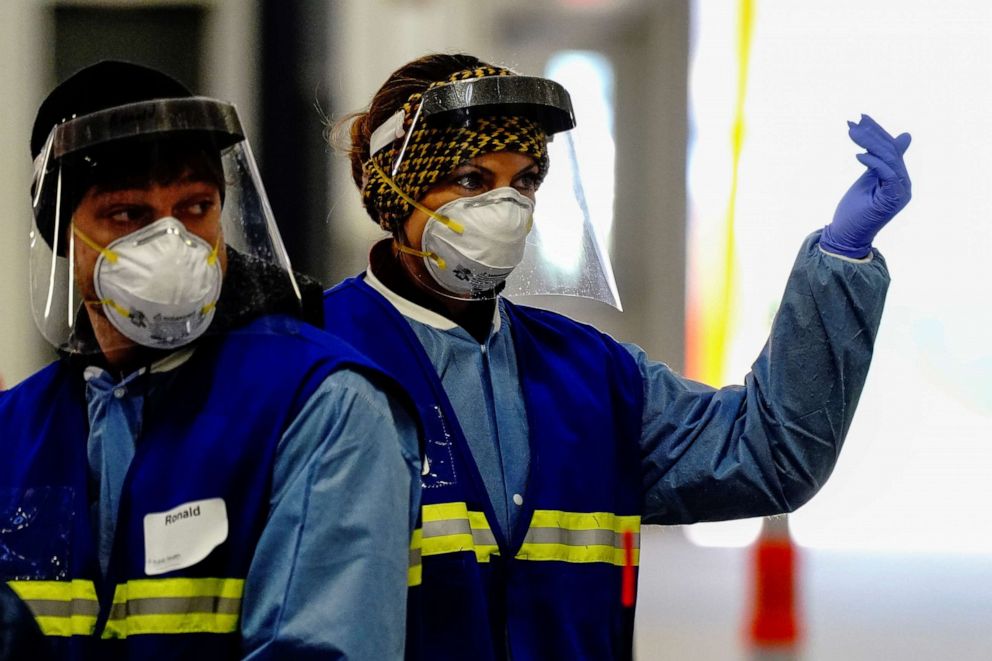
[362,66,548,231]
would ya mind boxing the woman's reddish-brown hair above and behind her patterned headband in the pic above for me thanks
[330,53,487,190]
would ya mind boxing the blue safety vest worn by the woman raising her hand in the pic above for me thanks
[324,278,643,661]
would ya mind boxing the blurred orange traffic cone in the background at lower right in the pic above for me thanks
[748,516,800,661]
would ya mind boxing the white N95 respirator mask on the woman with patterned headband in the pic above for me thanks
[421,188,534,297]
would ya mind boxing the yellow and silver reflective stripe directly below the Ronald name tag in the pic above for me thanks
[103,578,245,638]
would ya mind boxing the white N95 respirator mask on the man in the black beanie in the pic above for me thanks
[73,216,223,349]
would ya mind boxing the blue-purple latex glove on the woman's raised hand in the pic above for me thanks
[820,115,912,259]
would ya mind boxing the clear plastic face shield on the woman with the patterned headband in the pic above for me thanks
[370,76,621,309]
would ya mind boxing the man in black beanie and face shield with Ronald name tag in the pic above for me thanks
[0,62,419,660]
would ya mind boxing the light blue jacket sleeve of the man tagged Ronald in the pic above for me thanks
[241,370,420,659]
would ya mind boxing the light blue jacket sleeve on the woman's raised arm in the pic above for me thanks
[626,234,889,524]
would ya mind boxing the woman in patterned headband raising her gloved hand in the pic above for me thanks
[325,55,909,659]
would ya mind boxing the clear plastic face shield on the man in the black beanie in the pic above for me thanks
[30,97,300,353]
